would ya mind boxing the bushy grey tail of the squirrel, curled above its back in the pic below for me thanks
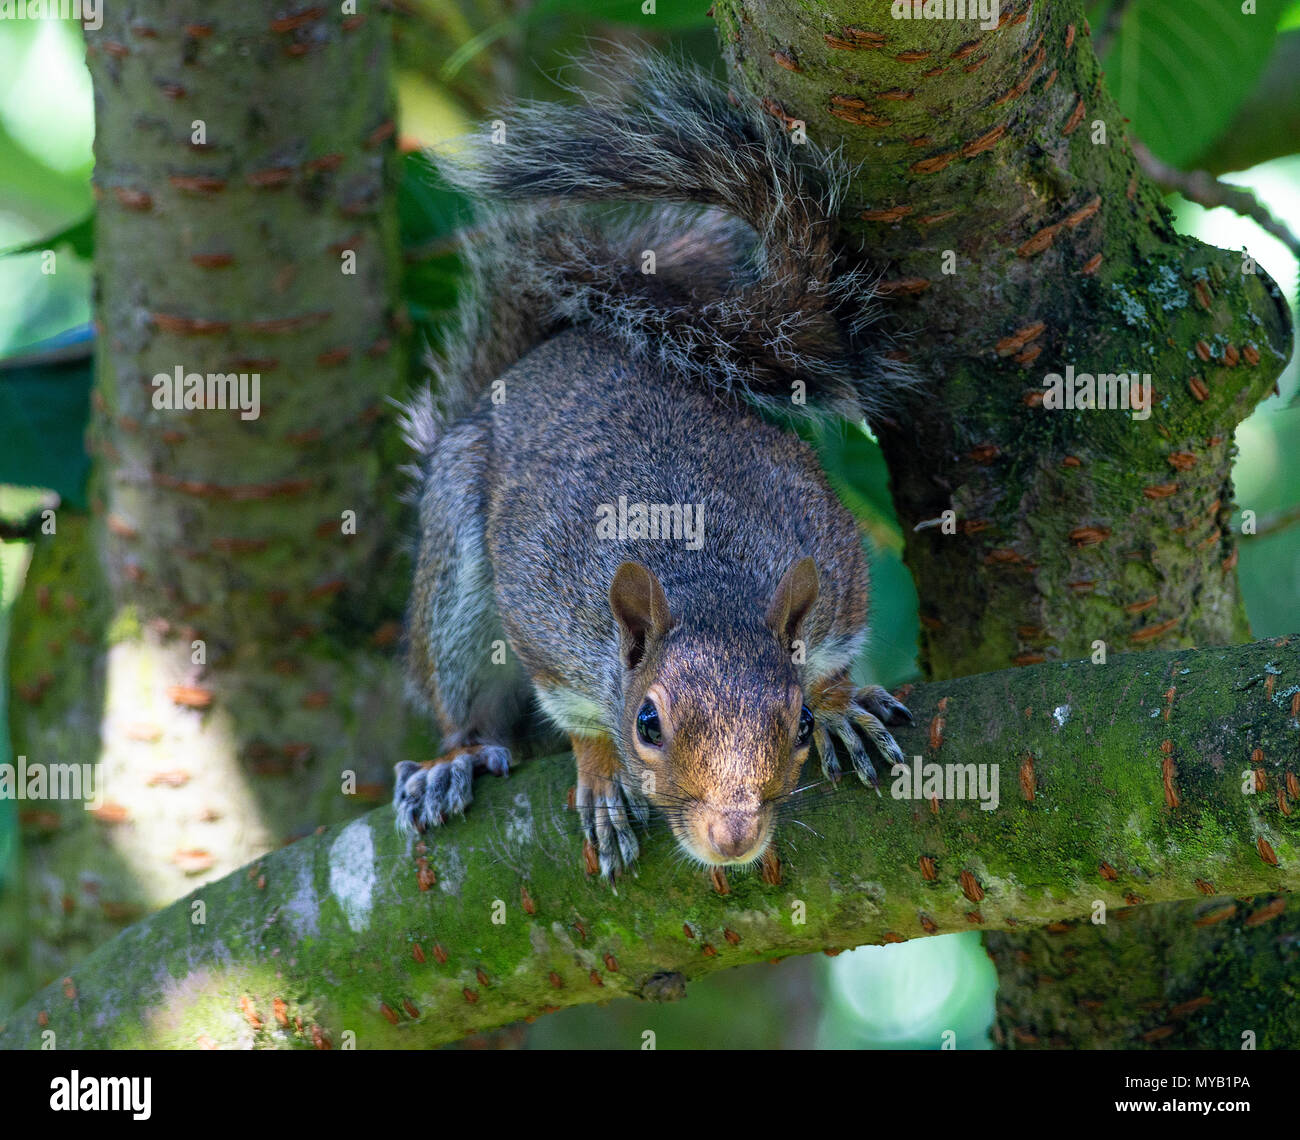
[410,51,907,457]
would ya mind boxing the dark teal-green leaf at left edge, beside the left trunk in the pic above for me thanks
[0,326,94,508]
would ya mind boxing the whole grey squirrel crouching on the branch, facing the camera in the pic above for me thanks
[394,52,914,880]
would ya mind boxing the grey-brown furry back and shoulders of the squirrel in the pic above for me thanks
[483,329,867,722]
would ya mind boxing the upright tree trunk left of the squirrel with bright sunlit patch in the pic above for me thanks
[0,0,418,1005]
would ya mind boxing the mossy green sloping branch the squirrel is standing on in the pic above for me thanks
[0,638,1300,1048]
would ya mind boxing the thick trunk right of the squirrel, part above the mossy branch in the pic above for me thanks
[715,0,1291,677]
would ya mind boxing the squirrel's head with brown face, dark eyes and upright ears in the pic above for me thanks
[610,558,818,866]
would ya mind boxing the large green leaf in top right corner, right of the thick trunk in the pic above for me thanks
[1102,0,1287,166]
